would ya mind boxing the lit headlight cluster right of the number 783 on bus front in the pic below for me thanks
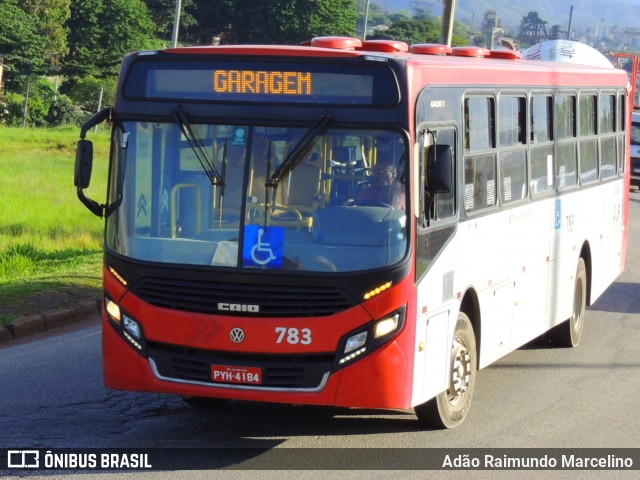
[334,307,405,370]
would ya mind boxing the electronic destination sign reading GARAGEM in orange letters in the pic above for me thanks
[123,55,400,106]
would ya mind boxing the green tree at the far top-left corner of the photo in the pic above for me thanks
[0,0,45,91]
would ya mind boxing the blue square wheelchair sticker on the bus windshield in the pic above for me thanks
[242,225,284,267]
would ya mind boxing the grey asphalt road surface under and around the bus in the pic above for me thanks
[0,193,640,480]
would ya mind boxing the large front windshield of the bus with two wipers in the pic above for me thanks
[106,121,408,272]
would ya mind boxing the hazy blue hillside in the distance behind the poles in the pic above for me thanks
[382,0,640,29]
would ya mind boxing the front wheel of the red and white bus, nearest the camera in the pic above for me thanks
[415,312,478,428]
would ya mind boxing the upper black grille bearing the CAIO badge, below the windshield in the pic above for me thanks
[132,278,355,317]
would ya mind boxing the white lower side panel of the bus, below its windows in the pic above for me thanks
[412,179,624,405]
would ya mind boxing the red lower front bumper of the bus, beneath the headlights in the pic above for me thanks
[102,315,412,409]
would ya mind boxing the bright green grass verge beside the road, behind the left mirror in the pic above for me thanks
[0,127,109,324]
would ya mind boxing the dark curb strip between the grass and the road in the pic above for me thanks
[0,300,100,344]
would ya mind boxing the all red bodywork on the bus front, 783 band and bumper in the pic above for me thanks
[102,271,415,409]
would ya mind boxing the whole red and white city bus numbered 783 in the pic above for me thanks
[75,37,630,427]
